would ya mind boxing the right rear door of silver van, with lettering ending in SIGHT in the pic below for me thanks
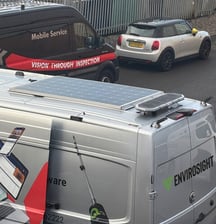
[188,109,216,224]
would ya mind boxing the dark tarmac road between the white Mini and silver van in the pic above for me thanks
[119,50,216,111]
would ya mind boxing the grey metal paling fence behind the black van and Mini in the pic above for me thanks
[0,0,216,35]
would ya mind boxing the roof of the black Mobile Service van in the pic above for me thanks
[0,2,82,29]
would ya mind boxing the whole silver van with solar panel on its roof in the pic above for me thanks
[0,69,216,224]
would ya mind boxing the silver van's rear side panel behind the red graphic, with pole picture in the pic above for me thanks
[46,119,137,223]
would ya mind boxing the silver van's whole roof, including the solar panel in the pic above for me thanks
[0,69,209,130]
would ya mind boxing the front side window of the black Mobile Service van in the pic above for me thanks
[74,22,96,50]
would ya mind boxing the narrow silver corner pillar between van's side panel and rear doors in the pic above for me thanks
[134,128,155,223]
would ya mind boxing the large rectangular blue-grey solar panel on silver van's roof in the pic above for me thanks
[10,77,162,109]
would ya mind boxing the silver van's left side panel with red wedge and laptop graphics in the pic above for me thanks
[0,108,51,223]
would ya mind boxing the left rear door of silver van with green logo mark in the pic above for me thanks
[153,118,193,224]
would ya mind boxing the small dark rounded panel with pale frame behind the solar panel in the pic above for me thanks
[135,93,184,113]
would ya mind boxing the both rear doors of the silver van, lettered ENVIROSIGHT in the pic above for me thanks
[154,109,216,224]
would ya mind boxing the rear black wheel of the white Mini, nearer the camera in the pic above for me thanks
[158,51,174,72]
